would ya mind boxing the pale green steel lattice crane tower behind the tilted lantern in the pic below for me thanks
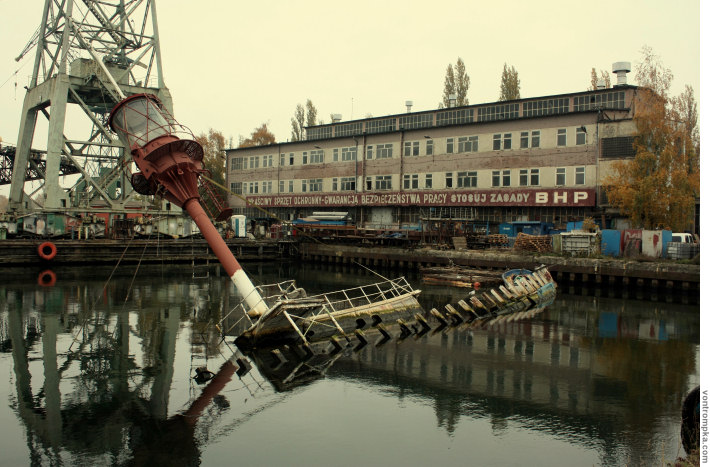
[9,0,172,214]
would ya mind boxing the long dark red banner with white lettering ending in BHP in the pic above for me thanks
[246,188,596,207]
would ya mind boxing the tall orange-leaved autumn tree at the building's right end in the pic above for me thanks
[603,47,700,231]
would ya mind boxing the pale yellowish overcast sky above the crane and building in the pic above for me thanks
[0,0,700,147]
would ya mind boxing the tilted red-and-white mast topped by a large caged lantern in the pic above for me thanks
[109,94,267,315]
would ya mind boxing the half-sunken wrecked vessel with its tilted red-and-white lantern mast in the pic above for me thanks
[109,94,555,354]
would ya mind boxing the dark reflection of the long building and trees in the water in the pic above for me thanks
[328,299,699,463]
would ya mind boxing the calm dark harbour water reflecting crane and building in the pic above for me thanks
[0,264,700,466]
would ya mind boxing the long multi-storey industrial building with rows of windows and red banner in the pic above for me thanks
[227,84,636,232]
